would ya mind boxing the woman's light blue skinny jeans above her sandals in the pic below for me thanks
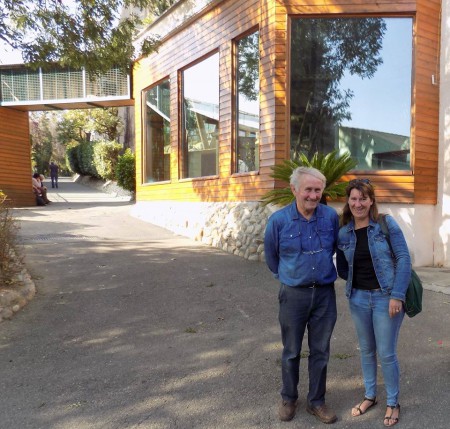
[350,289,405,406]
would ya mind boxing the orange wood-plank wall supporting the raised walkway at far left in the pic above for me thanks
[0,107,35,207]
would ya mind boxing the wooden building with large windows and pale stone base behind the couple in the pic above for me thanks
[133,0,442,265]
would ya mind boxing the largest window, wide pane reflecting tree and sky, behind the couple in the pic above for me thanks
[290,17,412,170]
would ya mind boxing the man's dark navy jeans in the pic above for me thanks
[278,284,337,407]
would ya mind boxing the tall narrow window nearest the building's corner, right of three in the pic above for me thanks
[235,31,259,173]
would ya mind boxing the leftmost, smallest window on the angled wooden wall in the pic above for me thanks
[143,80,170,183]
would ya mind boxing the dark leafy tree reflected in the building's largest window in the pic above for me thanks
[291,18,386,159]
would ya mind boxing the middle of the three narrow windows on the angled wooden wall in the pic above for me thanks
[181,53,219,178]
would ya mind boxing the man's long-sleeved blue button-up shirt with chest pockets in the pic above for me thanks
[264,201,339,286]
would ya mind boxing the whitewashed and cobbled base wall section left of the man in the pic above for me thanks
[131,201,274,261]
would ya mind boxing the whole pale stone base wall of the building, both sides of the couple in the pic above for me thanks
[131,201,438,267]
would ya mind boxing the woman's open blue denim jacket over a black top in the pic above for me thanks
[336,216,411,301]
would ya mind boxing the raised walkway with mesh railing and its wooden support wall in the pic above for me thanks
[0,64,134,207]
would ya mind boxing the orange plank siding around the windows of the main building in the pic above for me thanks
[133,0,440,204]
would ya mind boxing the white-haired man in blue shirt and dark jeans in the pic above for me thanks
[264,167,339,423]
